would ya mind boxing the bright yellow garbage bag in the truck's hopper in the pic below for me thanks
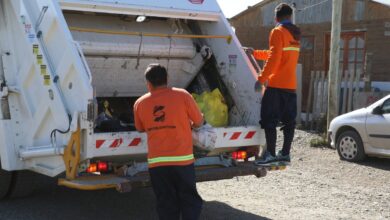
[192,89,228,127]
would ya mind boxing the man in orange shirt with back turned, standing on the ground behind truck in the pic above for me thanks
[134,64,203,220]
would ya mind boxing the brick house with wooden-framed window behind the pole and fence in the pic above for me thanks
[230,0,390,109]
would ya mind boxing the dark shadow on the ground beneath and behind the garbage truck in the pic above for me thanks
[0,177,268,220]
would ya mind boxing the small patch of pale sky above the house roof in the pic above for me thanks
[217,0,262,18]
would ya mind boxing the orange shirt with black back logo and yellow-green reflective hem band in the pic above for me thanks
[134,88,203,168]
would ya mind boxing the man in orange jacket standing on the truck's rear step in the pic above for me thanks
[253,3,301,164]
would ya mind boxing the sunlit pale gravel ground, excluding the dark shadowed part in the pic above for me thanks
[199,131,390,219]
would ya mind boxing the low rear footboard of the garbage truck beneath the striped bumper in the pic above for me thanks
[58,162,269,193]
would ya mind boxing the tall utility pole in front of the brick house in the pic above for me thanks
[327,0,343,130]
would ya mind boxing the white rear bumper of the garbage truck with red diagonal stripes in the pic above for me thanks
[87,126,265,160]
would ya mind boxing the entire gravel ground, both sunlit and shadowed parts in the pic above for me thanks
[0,131,390,220]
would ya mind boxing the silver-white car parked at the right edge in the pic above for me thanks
[329,95,390,162]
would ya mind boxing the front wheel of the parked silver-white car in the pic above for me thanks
[336,130,366,162]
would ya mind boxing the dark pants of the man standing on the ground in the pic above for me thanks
[149,164,203,220]
